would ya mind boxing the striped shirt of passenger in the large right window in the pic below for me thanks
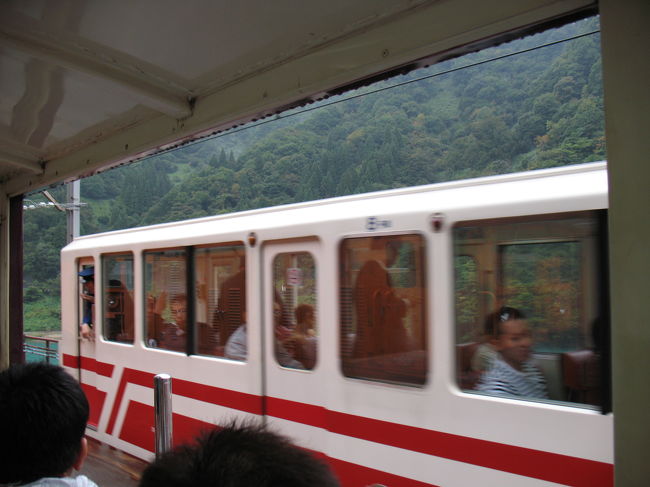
[476,356,548,399]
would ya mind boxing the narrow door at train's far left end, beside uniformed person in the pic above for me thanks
[76,257,101,428]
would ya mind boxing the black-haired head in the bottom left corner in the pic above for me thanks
[0,363,89,485]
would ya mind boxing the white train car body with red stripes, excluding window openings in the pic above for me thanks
[61,163,613,487]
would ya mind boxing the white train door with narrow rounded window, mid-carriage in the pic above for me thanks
[263,239,325,450]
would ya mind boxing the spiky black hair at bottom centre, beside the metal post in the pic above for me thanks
[140,423,339,487]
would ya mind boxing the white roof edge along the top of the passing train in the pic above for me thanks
[63,161,607,255]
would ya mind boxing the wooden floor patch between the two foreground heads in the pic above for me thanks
[79,438,147,487]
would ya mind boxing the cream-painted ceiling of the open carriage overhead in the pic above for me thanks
[0,0,593,195]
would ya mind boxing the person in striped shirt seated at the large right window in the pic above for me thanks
[476,307,548,399]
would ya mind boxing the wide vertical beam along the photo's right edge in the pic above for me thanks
[599,0,650,487]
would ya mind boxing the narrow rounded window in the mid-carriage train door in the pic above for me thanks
[273,252,318,370]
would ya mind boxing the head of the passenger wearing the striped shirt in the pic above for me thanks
[485,306,532,370]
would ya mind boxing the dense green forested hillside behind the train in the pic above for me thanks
[25,18,605,331]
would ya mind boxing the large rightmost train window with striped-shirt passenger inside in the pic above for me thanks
[453,211,606,405]
